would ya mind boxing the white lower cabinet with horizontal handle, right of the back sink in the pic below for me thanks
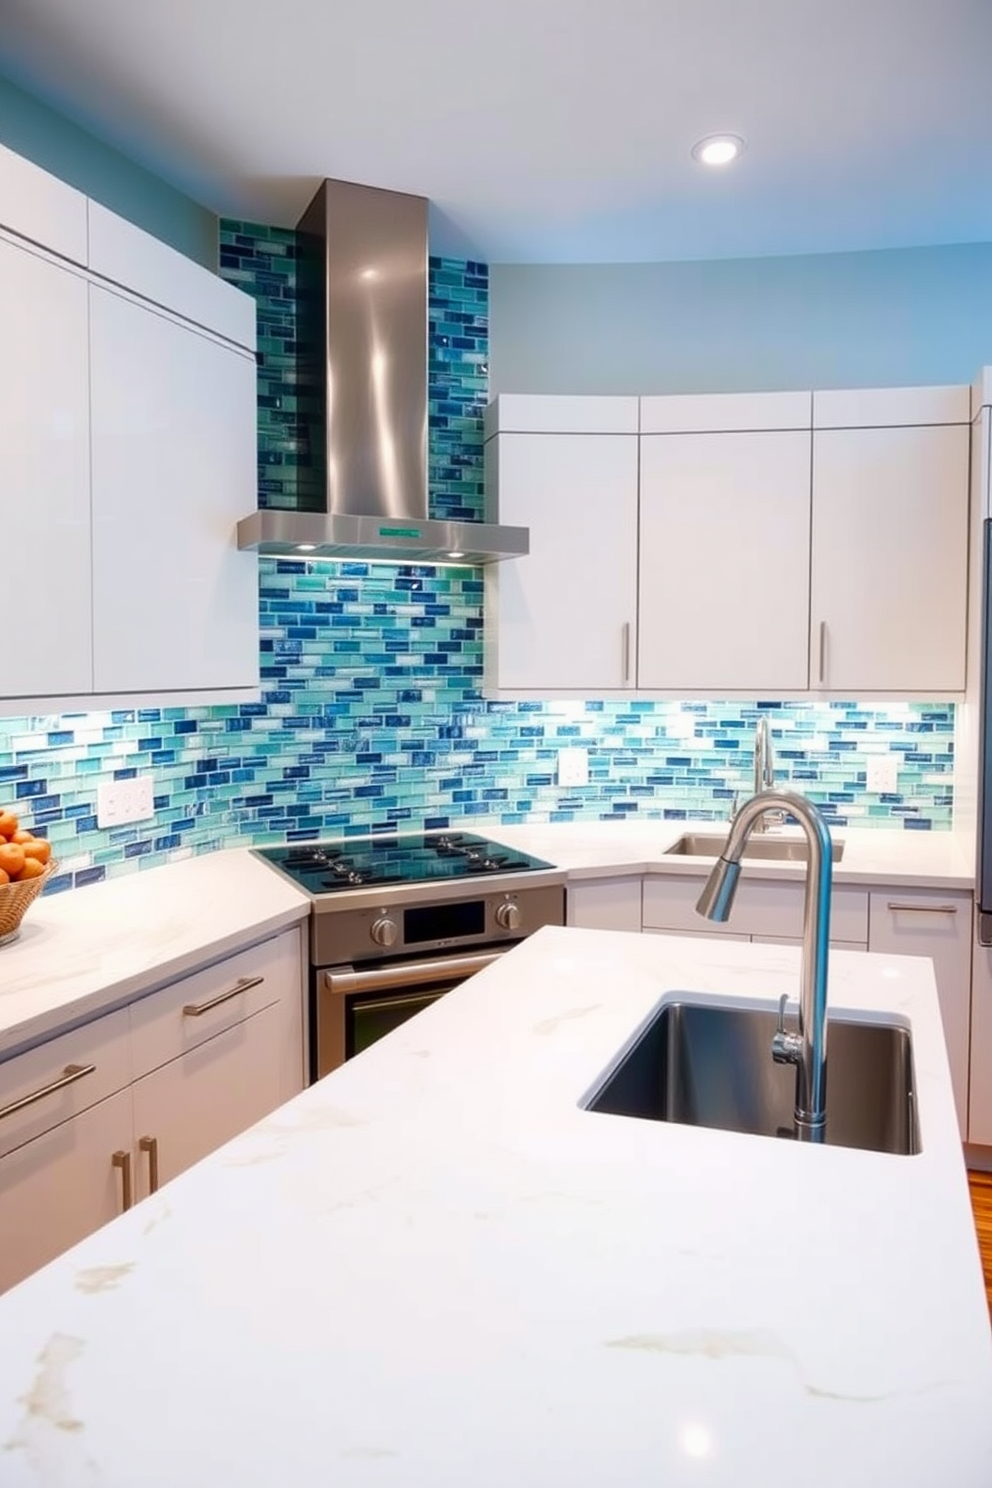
[869,888,975,1141]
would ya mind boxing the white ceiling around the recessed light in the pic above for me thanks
[0,0,992,263]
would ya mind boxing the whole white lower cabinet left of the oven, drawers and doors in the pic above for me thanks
[0,927,305,1290]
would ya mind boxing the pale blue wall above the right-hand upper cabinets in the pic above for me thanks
[489,243,992,394]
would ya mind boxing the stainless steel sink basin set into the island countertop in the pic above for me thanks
[583,1000,921,1156]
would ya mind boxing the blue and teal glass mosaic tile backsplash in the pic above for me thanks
[0,222,955,888]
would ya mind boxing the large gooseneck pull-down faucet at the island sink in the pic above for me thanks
[696,790,833,1141]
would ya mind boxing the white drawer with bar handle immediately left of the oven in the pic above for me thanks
[131,936,291,1080]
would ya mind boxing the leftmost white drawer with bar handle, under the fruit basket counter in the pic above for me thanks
[0,1007,131,1158]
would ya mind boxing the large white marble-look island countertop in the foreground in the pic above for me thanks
[0,922,992,1488]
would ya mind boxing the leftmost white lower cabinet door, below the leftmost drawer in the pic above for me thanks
[0,1089,134,1292]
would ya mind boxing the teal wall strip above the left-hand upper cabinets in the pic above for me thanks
[0,69,217,269]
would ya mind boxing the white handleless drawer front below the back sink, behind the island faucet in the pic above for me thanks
[644,868,869,946]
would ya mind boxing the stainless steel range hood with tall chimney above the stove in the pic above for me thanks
[238,180,529,564]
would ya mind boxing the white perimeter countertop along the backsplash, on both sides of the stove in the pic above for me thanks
[0,820,974,1056]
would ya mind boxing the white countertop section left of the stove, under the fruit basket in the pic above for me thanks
[0,850,309,1059]
